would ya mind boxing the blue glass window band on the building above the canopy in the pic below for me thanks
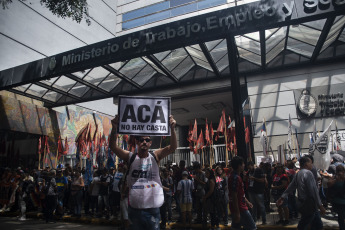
[122,0,227,30]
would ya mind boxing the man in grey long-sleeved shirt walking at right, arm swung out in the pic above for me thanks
[277,156,326,230]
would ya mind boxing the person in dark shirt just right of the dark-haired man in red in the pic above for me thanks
[247,162,266,225]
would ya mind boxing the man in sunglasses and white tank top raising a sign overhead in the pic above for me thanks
[109,95,177,230]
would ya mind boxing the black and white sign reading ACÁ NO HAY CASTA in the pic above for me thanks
[118,96,171,136]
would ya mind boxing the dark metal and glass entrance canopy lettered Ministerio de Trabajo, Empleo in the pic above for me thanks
[0,0,345,107]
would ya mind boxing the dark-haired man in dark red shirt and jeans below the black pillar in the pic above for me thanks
[228,156,256,230]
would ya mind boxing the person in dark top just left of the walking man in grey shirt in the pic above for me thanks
[271,164,289,225]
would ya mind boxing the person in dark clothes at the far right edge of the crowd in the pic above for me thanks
[328,164,345,230]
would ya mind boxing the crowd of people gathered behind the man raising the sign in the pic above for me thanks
[0,154,345,230]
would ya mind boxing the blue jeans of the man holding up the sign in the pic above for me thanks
[128,206,160,230]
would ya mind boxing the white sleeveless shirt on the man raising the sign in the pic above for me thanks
[127,152,164,209]
